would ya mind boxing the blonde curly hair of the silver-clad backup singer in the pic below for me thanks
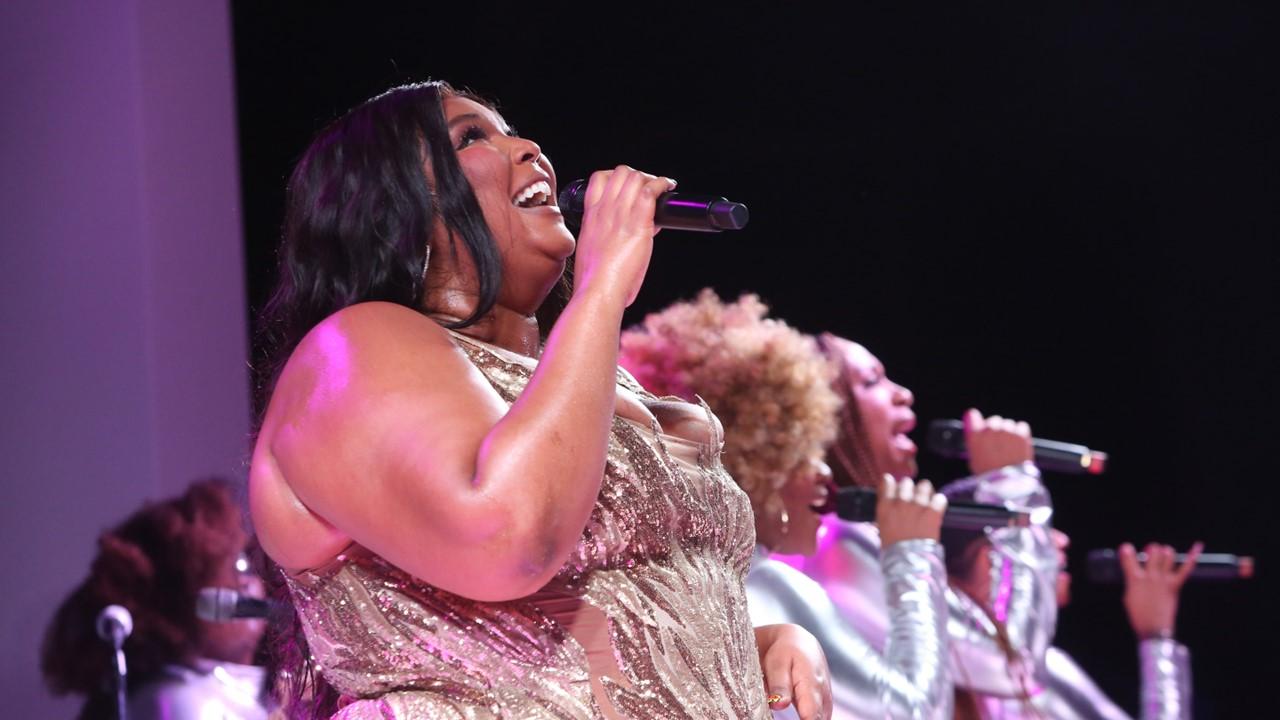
[618,288,840,507]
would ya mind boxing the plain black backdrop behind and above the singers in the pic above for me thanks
[233,3,1280,719]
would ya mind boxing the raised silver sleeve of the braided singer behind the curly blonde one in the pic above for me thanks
[943,462,1059,697]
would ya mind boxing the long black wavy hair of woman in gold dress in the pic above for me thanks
[257,81,502,406]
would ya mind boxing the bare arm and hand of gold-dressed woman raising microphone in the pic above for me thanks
[250,168,671,601]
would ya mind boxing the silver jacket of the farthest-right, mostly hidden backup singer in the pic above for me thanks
[979,639,1192,720]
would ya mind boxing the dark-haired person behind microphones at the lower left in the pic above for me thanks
[41,479,273,720]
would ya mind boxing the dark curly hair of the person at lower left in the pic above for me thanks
[40,478,248,717]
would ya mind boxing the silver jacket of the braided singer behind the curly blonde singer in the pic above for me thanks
[803,462,1057,698]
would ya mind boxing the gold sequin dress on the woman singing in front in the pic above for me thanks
[288,336,769,720]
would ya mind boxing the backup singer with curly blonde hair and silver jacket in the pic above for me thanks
[620,290,952,719]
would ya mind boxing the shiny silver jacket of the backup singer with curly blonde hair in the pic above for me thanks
[746,539,955,720]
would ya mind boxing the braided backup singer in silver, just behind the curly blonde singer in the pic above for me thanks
[801,333,1059,711]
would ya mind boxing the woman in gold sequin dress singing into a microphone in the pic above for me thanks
[250,83,829,720]
